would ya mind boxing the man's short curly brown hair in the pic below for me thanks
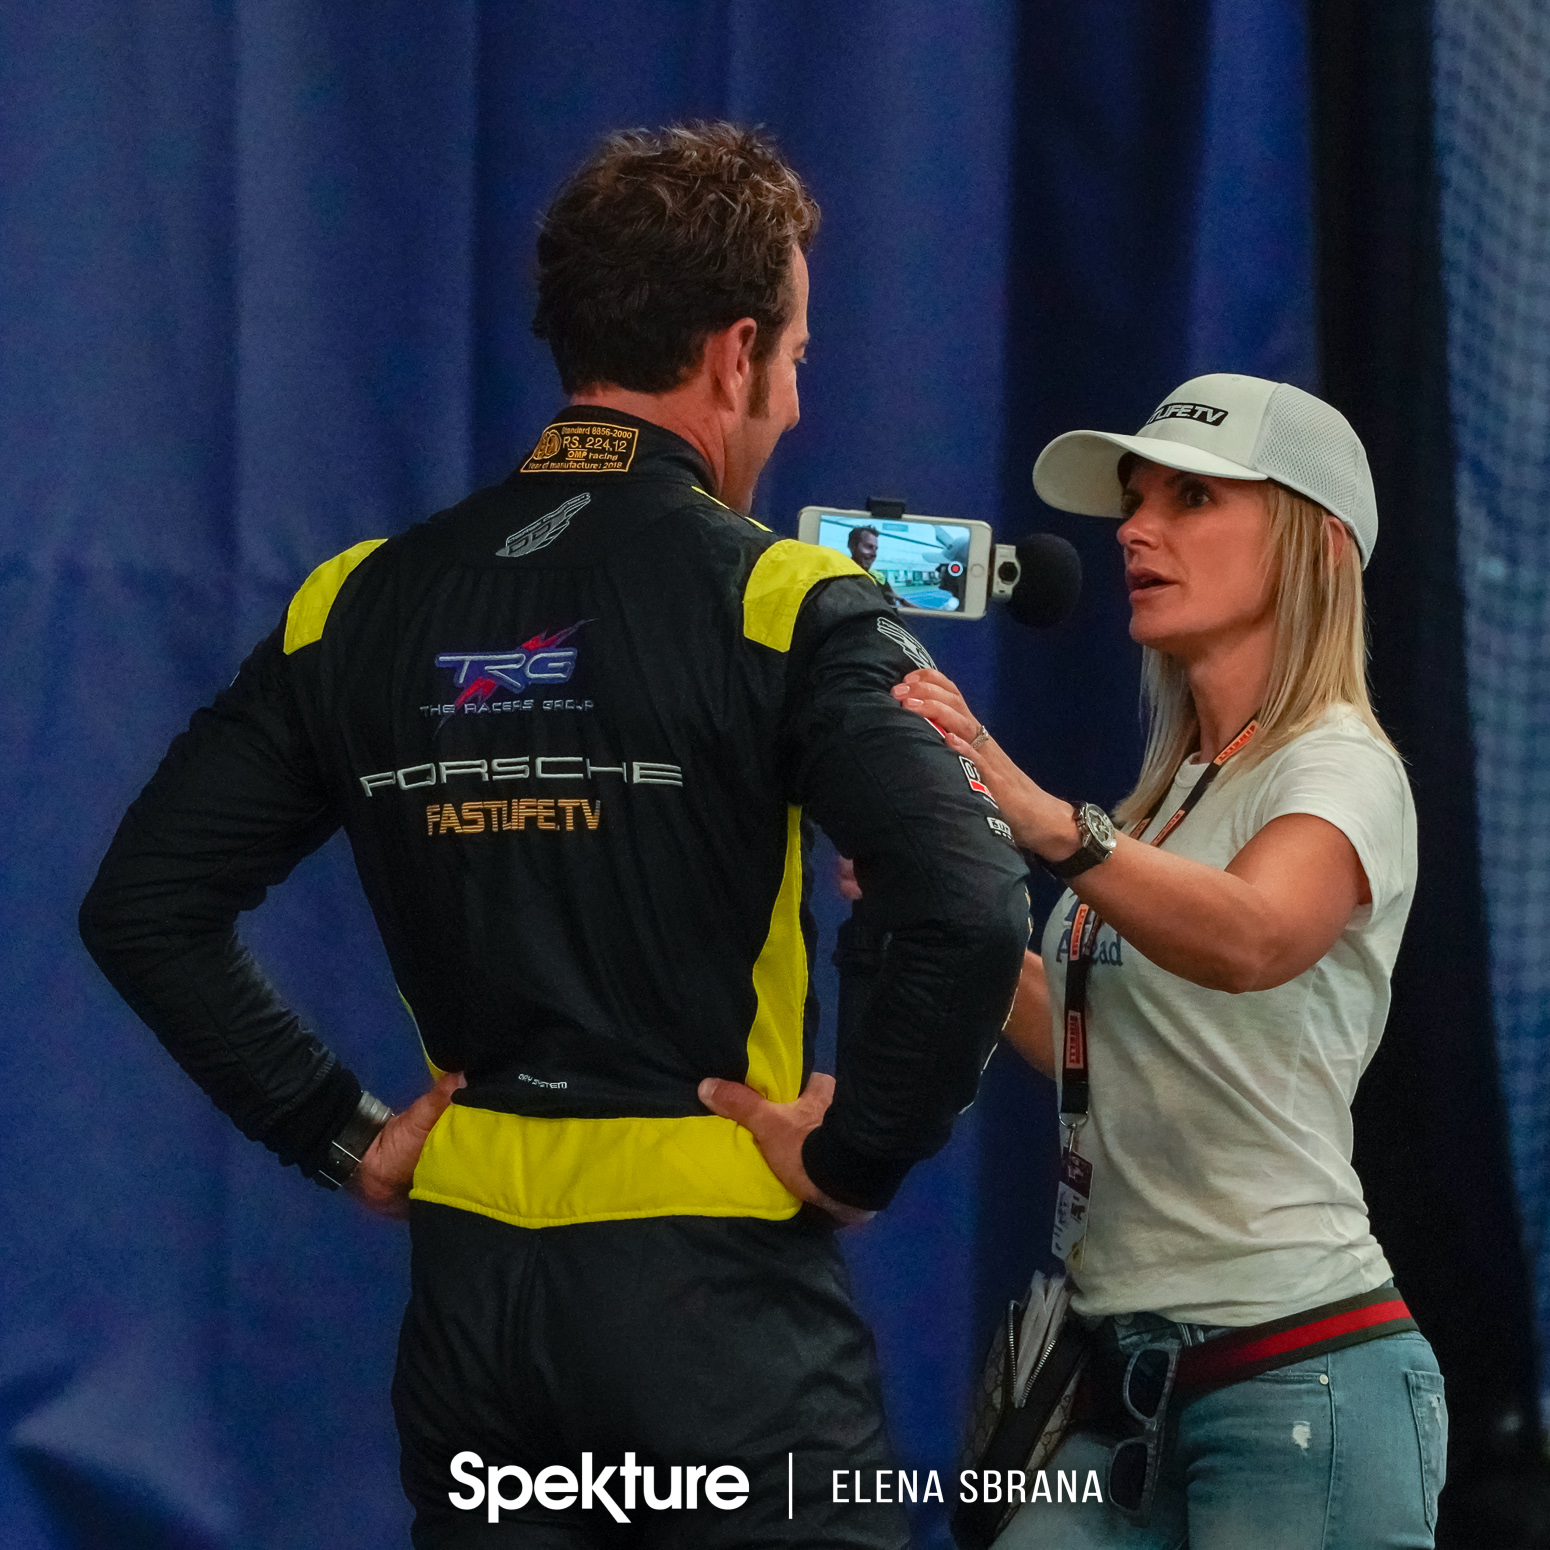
[533,122,818,394]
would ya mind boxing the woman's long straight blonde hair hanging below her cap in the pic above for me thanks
[1114,481,1393,823]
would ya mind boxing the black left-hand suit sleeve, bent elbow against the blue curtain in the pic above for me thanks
[81,631,361,1178]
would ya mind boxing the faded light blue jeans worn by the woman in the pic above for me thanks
[995,1313,1448,1550]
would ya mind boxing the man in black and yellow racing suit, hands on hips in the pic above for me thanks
[82,126,1028,1547]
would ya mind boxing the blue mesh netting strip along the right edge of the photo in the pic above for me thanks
[1435,0,1550,1415]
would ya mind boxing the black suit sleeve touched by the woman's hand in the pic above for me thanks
[787,578,1029,1209]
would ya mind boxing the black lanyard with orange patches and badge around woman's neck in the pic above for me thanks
[1049,711,1259,1269]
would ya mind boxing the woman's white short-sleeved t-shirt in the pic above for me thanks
[1043,705,1415,1325]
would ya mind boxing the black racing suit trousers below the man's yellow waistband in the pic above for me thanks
[394,1201,908,1550]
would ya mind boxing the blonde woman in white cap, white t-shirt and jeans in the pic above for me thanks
[894,375,1446,1550]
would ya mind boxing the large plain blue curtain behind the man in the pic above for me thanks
[0,0,1316,1550]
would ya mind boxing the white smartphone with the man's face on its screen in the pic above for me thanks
[797,505,992,618]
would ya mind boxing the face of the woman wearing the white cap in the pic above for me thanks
[1119,459,1276,662]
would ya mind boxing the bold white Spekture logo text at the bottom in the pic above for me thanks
[446,1452,749,1524]
